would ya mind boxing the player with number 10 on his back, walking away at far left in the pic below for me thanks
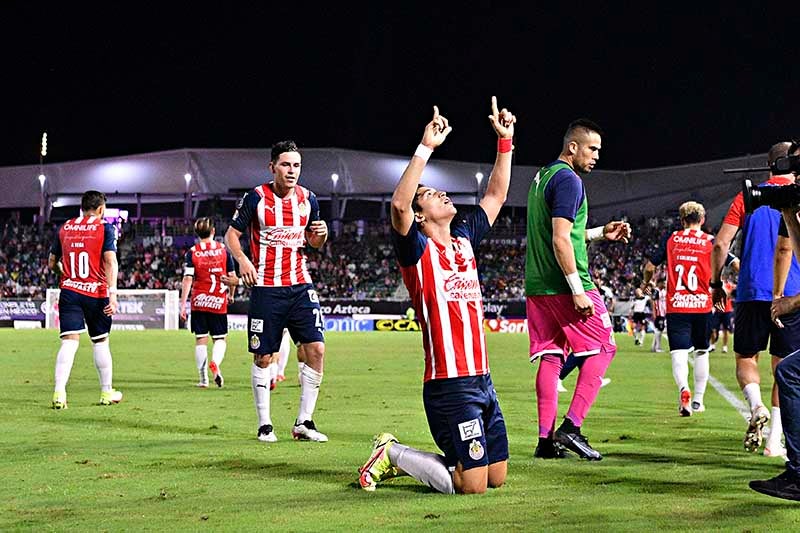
[47,191,122,409]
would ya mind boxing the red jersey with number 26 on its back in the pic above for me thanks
[666,229,714,313]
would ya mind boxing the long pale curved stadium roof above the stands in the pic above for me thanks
[0,148,766,225]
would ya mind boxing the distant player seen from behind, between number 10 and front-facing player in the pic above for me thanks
[181,217,239,388]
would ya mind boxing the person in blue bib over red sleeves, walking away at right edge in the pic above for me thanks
[711,142,800,457]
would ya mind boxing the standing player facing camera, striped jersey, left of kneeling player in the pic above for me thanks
[225,141,328,442]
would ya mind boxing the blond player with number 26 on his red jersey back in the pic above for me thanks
[642,202,714,416]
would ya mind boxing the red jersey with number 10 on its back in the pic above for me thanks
[51,216,117,298]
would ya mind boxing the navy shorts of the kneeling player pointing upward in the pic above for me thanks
[422,374,508,470]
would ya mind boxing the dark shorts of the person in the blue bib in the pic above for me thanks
[733,302,800,357]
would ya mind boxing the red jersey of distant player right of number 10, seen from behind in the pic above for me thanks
[183,241,234,314]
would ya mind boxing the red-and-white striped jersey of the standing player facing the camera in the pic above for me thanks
[231,183,320,287]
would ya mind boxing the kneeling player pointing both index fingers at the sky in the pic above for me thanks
[359,97,516,494]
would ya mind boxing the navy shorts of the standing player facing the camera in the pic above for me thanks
[247,283,325,355]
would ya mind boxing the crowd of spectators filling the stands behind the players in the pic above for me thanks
[0,211,696,300]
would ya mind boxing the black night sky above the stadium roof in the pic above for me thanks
[0,2,800,170]
